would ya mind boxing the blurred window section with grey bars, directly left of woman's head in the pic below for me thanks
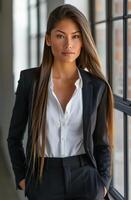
[28,0,47,67]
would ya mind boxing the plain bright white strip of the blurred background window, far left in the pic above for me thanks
[13,0,28,91]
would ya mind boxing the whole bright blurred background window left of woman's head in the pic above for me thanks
[13,0,47,90]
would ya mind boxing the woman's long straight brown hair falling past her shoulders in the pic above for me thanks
[31,4,113,179]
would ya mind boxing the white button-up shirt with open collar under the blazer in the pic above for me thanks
[40,68,85,157]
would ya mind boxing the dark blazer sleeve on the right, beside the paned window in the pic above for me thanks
[93,84,112,190]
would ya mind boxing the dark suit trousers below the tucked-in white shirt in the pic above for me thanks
[27,154,104,200]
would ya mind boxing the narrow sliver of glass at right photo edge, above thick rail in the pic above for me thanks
[127,19,131,100]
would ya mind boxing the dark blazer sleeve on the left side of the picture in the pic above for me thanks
[7,71,28,189]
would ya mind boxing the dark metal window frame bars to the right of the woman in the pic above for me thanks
[89,0,131,200]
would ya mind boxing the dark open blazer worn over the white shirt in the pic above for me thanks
[7,67,111,198]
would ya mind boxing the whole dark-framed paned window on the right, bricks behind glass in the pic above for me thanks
[89,0,131,200]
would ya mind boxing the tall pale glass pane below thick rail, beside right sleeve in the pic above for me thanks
[113,110,124,196]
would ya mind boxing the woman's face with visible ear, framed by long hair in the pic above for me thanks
[46,19,82,62]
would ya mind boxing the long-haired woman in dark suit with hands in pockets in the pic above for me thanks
[8,4,113,200]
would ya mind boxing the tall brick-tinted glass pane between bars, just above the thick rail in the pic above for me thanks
[112,21,123,97]
